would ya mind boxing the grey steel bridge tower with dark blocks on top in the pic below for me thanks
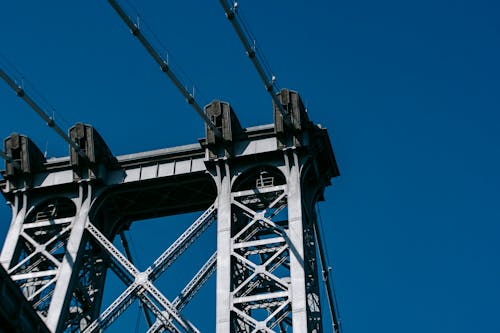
[0,89,338,333]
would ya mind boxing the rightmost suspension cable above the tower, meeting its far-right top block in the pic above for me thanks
[220,0,293,128]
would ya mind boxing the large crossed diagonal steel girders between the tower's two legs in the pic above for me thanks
[83,205,217,333]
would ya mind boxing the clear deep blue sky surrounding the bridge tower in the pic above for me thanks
[0,0,500,333]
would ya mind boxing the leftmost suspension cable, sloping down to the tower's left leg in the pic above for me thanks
[0,68,87,159]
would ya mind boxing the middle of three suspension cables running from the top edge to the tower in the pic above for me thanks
[108,0,222,138]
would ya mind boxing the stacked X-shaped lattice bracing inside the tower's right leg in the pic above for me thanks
[231,178,292,332]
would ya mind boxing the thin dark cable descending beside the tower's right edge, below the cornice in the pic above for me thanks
[314,205,343,333]
